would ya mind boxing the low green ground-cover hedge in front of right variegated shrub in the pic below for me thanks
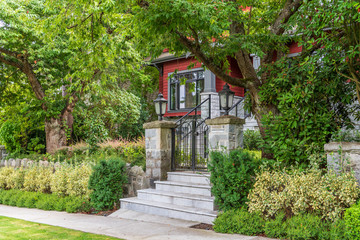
[214,208,348,240]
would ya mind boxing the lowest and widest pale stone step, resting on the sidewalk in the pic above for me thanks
[120,198,217,224]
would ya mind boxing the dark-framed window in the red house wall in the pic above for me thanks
[169,70,204,110]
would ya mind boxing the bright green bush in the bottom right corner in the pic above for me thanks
[344,204,360,239]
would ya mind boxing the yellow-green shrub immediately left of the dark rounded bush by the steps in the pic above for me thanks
[66,164,92,197]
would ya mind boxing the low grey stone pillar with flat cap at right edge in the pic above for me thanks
[324,142,360,184]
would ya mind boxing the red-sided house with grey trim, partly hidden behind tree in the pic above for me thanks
[151,43,302,130]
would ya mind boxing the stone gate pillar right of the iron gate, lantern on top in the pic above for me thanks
[206,115,245,152]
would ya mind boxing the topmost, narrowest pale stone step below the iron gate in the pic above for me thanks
[168,172,210,185]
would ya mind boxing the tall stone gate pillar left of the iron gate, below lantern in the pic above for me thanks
[144,121,176,186]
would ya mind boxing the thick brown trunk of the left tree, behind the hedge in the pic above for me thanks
[45,112,74,153]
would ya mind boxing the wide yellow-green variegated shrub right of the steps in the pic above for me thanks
[248,170,360,220]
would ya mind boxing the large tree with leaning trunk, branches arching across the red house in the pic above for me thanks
[132,0,360,136]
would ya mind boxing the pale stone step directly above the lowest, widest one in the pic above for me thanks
[137,189,216,211]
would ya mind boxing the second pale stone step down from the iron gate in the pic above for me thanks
[155,181,211,197]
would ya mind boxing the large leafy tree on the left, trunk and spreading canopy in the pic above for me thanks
[0,0,146,153]
